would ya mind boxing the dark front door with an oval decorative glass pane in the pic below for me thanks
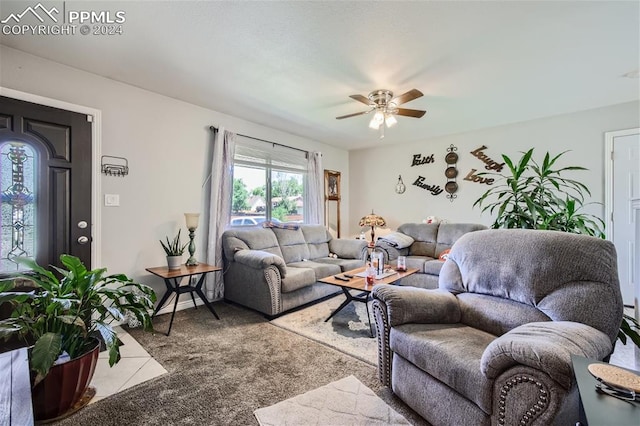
[0,96,92,274]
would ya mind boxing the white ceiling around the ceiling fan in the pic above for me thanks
[0,0,640,149]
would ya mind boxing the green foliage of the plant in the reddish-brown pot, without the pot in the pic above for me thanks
[0,255,156,418]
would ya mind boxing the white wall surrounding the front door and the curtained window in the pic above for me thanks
[0,46,349,294]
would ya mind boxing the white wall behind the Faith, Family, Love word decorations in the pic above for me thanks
[345,102,640,235]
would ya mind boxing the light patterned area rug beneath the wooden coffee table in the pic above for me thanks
[271,295,378,366]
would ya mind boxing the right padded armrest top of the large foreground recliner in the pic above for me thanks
[480,321,612,389]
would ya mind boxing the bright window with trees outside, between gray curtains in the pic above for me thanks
[230,136,307,226]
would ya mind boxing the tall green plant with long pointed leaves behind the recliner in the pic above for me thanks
[473,148,640,348]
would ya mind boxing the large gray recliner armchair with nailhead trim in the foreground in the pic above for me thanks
[373,230,623,426]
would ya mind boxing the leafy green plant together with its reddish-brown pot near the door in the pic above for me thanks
[0,254,156,420]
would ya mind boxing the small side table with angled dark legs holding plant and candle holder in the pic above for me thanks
[146,263,222,336]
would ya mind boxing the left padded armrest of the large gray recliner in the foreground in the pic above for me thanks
[371,284,461,327]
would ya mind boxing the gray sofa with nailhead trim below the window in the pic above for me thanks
[222,225,367,317]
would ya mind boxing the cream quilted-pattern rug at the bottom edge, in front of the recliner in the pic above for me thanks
[253,376,410,426]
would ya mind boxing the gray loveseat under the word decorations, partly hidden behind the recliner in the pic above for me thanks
[376,223,487,289]
